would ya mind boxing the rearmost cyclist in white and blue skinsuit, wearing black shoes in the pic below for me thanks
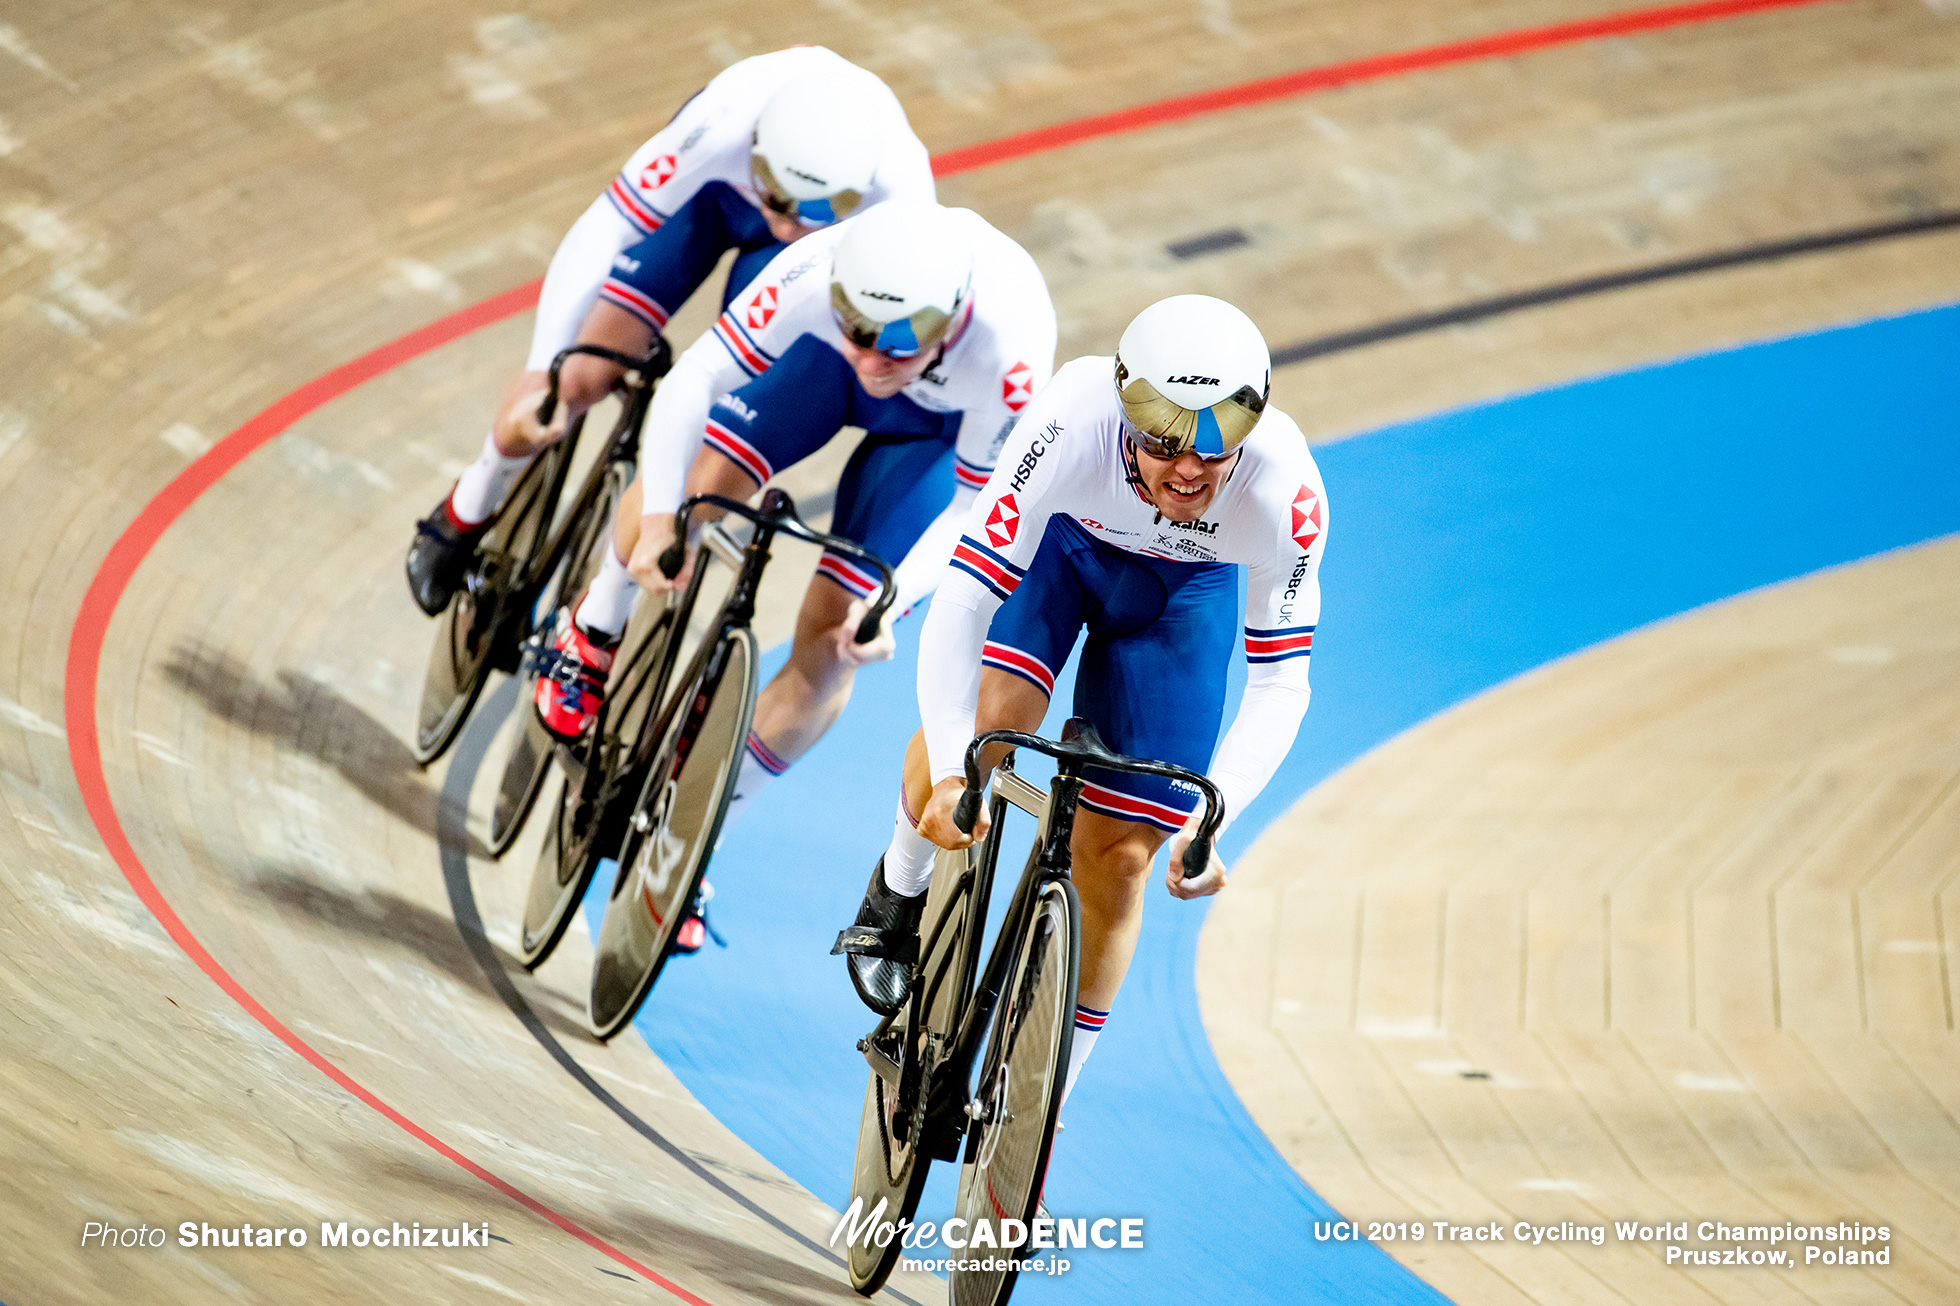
[408,45,933,616]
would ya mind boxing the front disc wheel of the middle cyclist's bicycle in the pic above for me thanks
[588,628,757,1039]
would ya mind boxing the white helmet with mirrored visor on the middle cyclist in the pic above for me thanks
[831,200,974,359]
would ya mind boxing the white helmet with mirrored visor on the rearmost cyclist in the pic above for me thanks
[749,69,884,227]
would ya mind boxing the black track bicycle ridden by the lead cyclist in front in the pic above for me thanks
[839,720,1225,1306]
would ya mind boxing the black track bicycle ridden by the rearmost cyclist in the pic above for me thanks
[414,335,674,784]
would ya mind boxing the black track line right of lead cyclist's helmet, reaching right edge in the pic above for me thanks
[1272,214,1960,367]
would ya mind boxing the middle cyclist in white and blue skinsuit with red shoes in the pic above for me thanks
[509,200,1054,949]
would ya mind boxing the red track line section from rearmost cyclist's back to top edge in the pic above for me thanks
[933,0,1833,176]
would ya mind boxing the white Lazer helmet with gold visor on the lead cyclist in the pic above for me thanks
[1115,294,1272,459]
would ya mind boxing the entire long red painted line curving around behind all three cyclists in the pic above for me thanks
[63,0,1827,1306]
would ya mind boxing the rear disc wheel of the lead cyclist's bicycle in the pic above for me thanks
[847,849,972,1296]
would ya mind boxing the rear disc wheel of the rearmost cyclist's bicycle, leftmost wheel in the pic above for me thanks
[414,439,572,767]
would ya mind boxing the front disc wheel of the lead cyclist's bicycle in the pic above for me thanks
[949,879,1082,1306]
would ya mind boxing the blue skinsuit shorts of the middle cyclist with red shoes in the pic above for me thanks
[708,335,976,598]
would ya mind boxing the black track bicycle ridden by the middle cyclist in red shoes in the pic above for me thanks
[519,488,898,1039]
